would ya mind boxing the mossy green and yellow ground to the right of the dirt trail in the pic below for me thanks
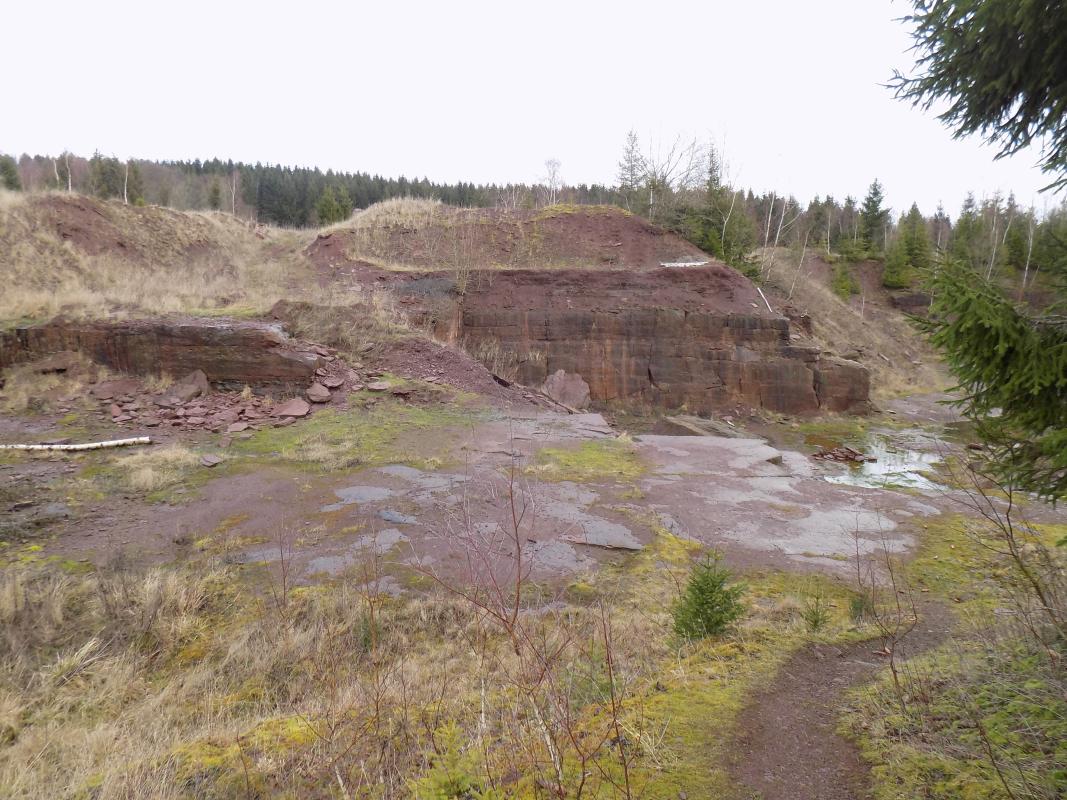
[843,515,1067,800]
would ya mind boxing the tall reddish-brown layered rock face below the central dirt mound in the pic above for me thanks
[439,270,870,414]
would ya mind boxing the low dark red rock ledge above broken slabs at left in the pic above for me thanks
[0,318,325,388]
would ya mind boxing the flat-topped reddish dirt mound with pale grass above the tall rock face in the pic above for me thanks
[306,201,710,273]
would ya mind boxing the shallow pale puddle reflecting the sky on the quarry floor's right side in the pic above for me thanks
[805,432,942,492]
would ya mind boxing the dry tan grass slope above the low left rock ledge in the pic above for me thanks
[0,193,308,320]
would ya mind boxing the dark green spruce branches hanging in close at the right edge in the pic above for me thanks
[896,0,1067,499]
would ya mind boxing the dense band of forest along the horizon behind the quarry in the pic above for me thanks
[0,142,1067,295]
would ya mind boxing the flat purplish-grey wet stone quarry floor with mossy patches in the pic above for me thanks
[8,398,954,586]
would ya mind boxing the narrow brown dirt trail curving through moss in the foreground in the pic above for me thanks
[728,604,953,800]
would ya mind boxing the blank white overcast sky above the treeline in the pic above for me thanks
[0,0,1052,215]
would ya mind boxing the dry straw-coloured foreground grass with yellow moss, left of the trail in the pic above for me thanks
[0,516,866,800]
